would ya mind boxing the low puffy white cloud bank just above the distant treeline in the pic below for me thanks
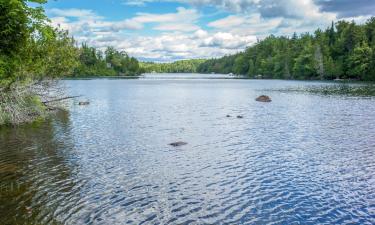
[79,30,256,61]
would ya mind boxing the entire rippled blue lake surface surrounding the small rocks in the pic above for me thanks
[0,74,375,224]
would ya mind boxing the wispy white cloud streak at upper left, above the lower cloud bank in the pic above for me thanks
[48,7,200,36]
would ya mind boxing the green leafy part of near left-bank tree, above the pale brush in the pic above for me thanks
[0,0,78,90]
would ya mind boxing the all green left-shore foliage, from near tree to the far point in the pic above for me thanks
[0,0,141,82]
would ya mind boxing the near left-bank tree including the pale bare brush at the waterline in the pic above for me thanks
[0,0,78,124]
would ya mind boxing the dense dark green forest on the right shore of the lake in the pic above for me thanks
[197,17,375,81]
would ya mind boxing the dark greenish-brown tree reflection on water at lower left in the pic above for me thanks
[0,111,78,224]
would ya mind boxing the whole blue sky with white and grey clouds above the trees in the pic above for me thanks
[45,0,375,62]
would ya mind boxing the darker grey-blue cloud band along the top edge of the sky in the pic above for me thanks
[124,0,375,18]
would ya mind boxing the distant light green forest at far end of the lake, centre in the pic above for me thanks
[140,59,206,73]
